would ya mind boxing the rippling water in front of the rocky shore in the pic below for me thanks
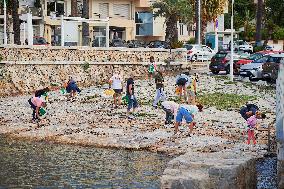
[0,136,170,188]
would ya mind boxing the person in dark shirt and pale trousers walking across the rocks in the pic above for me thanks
[153,68,166,108]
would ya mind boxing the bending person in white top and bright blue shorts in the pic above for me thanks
[175,104,203,134]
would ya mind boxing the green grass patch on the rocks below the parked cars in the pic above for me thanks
[198,93,256,110]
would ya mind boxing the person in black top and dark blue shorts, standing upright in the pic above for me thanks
[126,77,138,119]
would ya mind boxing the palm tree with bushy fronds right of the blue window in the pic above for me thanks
[152,0,193,43]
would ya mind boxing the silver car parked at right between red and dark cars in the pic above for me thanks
[240,55,271,81]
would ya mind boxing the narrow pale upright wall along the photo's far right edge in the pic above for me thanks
[276,64,284,188]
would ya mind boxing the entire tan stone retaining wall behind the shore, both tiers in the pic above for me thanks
[0,47,189,96]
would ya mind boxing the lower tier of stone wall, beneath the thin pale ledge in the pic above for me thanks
[0,64,190,96]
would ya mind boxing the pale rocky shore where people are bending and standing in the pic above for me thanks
[0,74,275,188]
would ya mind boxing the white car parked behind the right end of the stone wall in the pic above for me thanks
[183,44,216,61]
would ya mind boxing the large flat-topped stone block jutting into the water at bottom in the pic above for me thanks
[161,150,257,189]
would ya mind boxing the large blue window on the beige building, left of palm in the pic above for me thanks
[135,12,153,36]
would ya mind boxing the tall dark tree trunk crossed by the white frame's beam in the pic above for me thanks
[82,0,90,46]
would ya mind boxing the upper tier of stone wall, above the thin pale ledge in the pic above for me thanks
[0,46,186,64]
